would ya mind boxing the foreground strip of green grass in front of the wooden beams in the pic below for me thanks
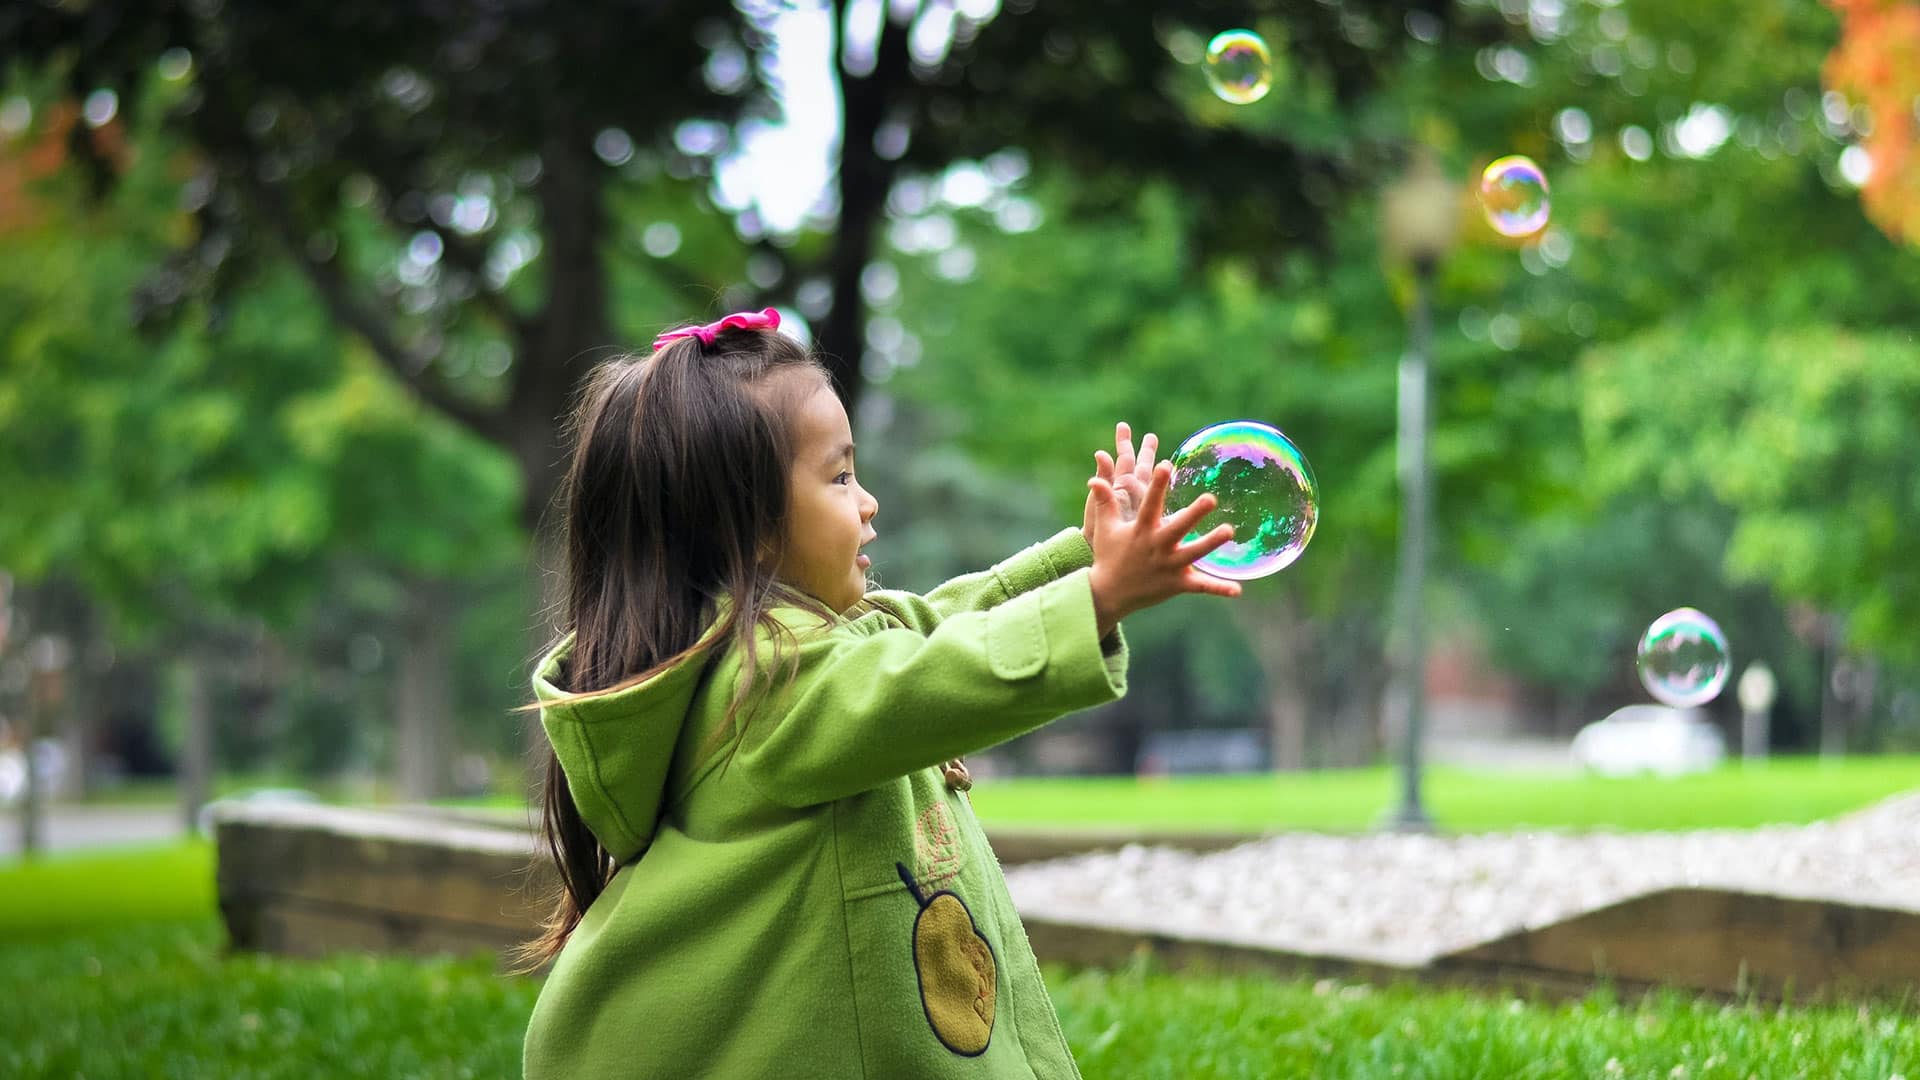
[0,919,1920,1080]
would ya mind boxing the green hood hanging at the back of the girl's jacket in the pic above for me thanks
[534,634,712,863]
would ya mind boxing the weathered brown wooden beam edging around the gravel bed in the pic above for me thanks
[213,803,1920,1001]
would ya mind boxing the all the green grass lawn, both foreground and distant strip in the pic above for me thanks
[0,759,1920,1080]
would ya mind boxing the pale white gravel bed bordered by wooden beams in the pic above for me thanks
[1006,794,1920,965]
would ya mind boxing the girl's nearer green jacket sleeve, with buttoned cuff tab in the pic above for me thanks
[733,571,1127,807]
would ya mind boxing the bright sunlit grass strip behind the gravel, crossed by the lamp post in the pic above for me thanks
[972,757,1920,832]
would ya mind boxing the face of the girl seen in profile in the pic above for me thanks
[778,384,879,611]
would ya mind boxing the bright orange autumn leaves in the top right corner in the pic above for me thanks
[1824,0,1920,246]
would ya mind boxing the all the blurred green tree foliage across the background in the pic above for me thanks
[0,0,1920,761]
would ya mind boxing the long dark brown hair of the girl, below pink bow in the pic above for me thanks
[518,320,828,969]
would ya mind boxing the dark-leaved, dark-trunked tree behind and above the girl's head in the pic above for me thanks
[0,0,1448,527]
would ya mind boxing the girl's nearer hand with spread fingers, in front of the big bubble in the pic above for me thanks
[1087,461,1240,638]
